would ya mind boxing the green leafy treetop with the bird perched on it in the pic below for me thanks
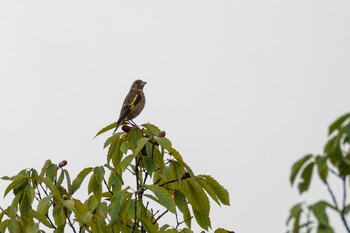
[0,124,234,233]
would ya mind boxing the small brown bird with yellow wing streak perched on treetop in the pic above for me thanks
[113,79,147,134]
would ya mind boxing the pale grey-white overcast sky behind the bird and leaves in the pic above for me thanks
[0,0,350,233]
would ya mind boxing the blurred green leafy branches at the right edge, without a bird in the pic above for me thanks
[287,113,350,233]
